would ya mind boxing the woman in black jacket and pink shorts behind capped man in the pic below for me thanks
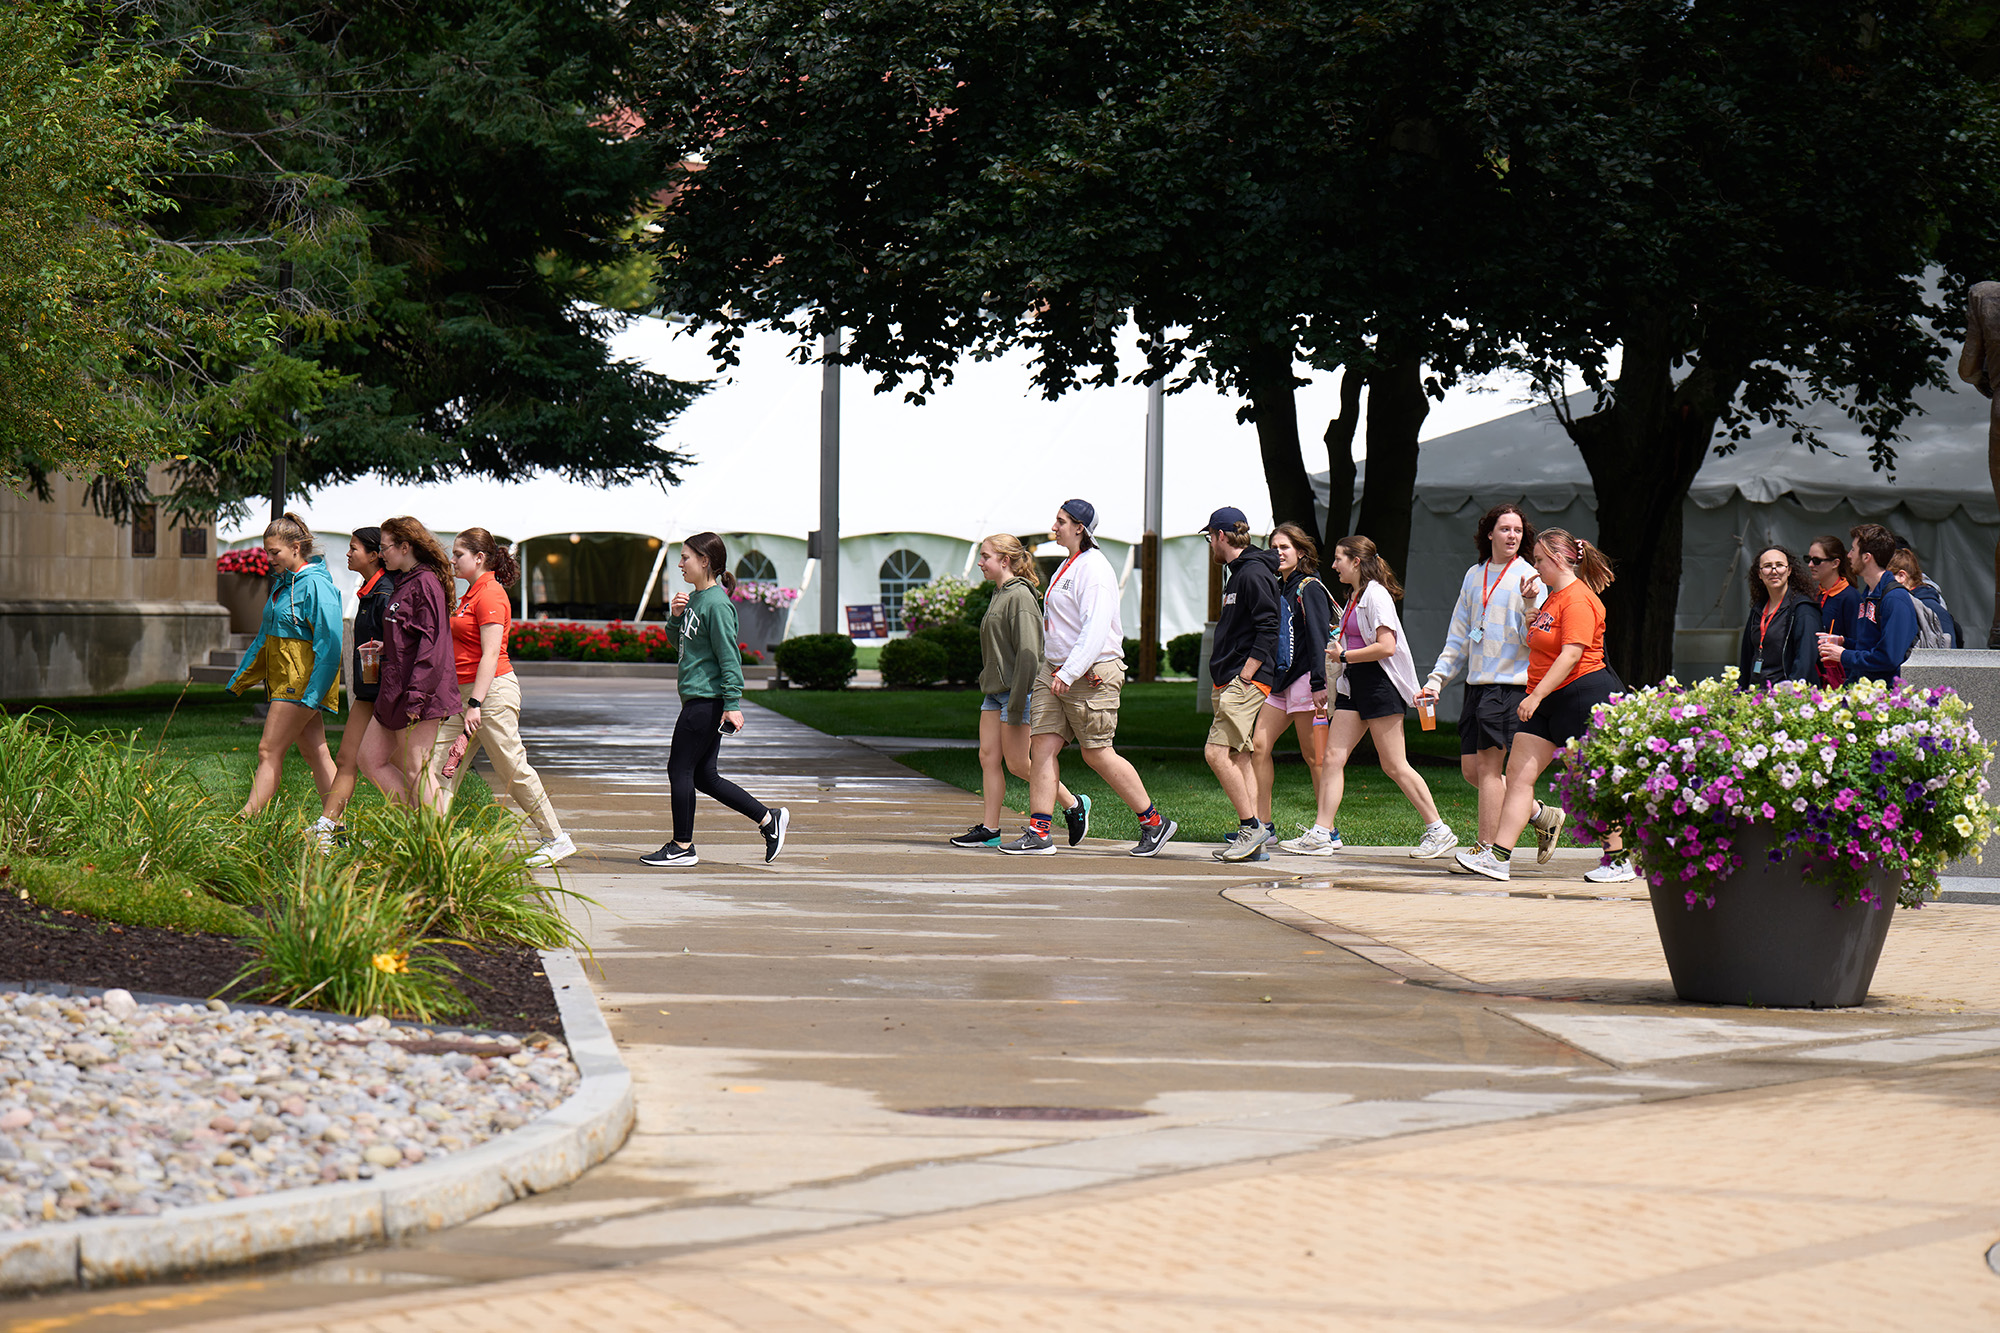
[1250,522,1334,840]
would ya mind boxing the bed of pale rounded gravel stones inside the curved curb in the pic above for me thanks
[0,991,578,1231]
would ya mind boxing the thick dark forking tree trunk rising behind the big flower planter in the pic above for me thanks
[1570,316,1746,685]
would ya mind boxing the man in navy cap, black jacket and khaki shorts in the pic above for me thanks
[1202,506,1288,861]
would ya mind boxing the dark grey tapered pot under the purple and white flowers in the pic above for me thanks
[1652,831,1896,1009]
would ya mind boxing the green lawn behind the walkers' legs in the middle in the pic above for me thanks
[754,681,1568,844]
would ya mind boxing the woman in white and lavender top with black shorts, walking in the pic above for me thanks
[1278,536,1458,861]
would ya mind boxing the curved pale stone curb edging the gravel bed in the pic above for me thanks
[0,949,634,1295]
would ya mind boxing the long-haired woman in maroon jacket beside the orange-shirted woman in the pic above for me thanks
[362,518,460,815]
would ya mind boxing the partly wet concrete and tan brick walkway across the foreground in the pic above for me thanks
[15,681,2000,1333]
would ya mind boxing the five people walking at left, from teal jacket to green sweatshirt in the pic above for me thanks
[228,512,790,867]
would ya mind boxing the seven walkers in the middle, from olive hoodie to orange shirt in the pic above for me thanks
[952,500,1634,883]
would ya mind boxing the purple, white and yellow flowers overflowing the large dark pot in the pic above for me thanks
[1556,667,1994,909]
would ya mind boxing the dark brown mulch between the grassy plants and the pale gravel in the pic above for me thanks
[0,893,562,1035]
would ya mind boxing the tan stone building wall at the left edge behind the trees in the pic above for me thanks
[0,476,228,699]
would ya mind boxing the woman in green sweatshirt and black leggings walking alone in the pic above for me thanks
[638,532,792,867]
